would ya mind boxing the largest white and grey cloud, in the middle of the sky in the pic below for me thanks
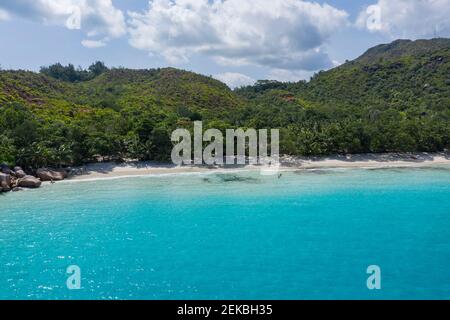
[129,0,348,70]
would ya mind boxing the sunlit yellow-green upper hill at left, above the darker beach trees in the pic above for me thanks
[0,65,238,116]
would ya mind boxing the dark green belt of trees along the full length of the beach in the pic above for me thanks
[0,99,450,169]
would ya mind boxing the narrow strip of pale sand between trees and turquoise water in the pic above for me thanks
[70,153,450,180]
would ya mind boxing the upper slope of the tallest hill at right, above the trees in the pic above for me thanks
[305,39,450,112]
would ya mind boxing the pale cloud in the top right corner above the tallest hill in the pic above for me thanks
[357,0,450,39]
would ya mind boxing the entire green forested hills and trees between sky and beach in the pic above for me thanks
[0,39,450,168]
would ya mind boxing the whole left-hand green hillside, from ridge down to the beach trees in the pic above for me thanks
[0,68,242,167]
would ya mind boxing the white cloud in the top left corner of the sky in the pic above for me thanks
[0,0,126,43]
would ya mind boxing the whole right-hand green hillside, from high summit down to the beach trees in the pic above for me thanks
[237,39,450,155]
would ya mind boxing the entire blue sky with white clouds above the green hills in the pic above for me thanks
[0,0,450,87]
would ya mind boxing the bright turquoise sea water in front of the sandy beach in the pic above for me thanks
[0,168,450,299]
